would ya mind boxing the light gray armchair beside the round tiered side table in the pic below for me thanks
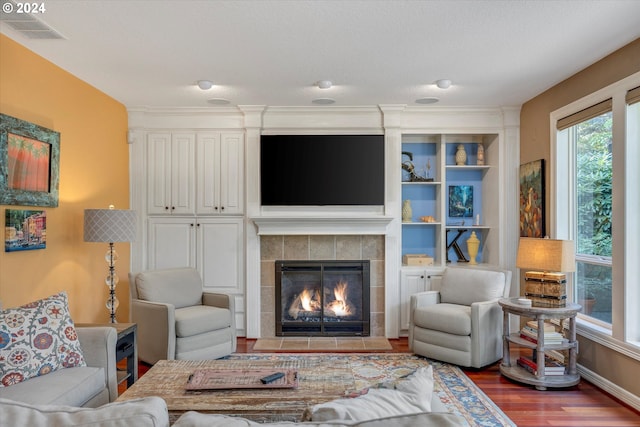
[409,267,511,368]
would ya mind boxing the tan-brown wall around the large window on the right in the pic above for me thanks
[520,39,640,396]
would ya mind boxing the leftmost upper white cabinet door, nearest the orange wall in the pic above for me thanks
[147,133,171,214]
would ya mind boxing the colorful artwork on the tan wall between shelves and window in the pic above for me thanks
[520,159,546,237]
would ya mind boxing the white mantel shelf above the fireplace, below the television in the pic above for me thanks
[250,216,393,236]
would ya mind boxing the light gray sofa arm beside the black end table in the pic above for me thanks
[76,326,118,402]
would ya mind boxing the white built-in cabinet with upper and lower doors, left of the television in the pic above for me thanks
[146,131,244,294]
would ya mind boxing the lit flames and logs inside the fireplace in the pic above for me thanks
[289,280,354,319]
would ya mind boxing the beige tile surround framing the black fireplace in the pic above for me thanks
[260,235,385,338]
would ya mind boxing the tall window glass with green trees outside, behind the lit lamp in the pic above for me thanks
[558,105,613,327]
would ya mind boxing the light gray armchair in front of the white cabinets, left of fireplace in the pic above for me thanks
[129,268,236,364]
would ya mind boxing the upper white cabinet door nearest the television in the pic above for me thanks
[220,132,244,215]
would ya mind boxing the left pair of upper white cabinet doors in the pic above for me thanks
[147,132,196,215]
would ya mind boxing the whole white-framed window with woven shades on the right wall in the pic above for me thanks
[550,73,640,359]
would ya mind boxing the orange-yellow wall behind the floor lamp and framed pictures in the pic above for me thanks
[0,34,129,322]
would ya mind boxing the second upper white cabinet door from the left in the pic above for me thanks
[171,133,196,215]
